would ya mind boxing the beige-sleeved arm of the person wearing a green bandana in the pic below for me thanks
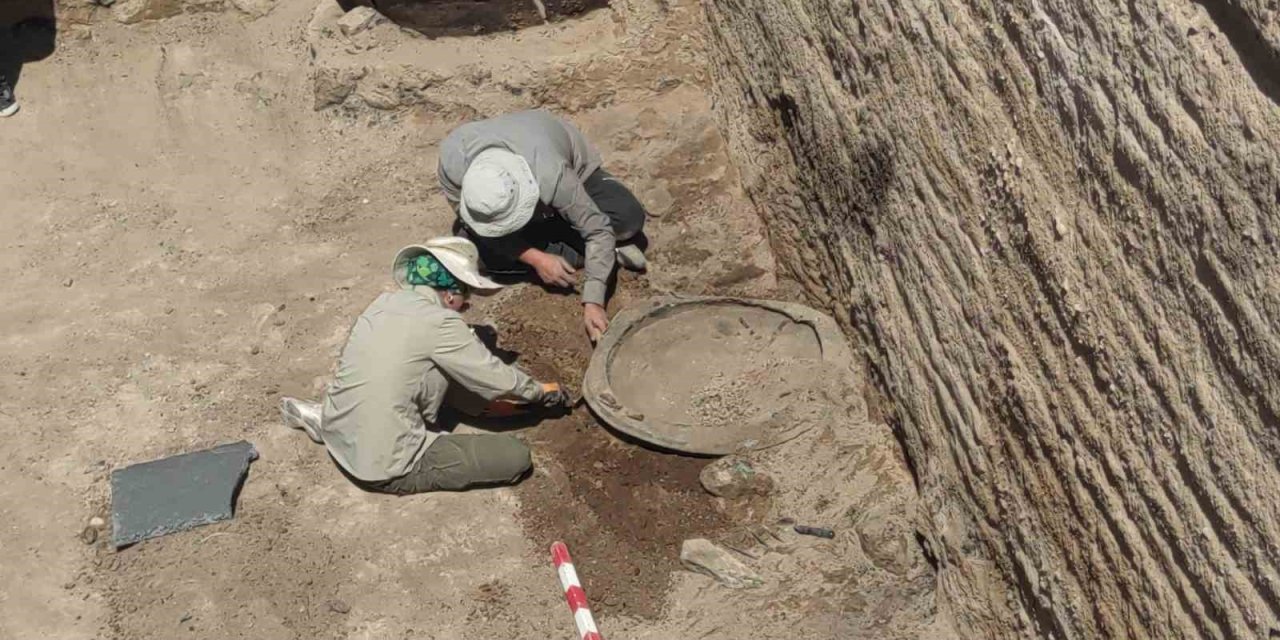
[431,314,544,402]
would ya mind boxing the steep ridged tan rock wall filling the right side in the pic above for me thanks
[705,0,1280,639]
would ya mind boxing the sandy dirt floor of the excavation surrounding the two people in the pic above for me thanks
[0,0,947,639]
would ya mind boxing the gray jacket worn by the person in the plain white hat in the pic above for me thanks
[436,111,616,305]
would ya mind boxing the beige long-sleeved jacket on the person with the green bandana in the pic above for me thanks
[320,287,543,481]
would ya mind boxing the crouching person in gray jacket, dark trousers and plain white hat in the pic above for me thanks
[436,111,648,342]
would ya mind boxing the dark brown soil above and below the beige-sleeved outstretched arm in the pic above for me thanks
[488,280,732,618]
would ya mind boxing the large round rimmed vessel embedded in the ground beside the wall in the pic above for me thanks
[584,297,850,456]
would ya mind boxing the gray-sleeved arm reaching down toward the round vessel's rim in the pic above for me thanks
[549,166,617,307]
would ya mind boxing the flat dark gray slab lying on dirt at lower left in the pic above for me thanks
[111,440,257,549]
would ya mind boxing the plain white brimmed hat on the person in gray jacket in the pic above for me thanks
[458,148,539,238]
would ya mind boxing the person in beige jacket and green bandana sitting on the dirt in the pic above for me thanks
[280,238,567,494]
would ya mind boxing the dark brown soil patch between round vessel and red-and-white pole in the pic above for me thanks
[516,410,732,618]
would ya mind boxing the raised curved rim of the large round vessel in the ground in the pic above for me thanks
[582,296,852,456]
